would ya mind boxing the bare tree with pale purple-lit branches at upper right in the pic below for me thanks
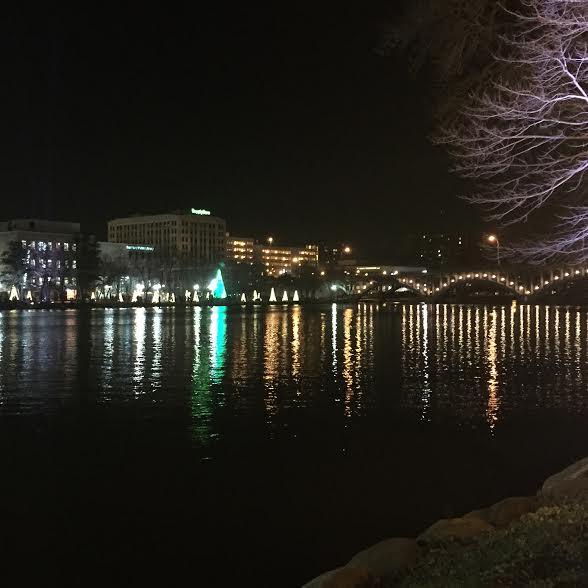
[437,0,588,263]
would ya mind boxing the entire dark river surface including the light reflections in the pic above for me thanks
[0,304,588,587]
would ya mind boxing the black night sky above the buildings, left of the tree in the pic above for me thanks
[0,0,475,254]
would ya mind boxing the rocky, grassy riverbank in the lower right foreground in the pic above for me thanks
[303,458,588,588]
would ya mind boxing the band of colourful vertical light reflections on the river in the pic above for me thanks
[0,304,588,434]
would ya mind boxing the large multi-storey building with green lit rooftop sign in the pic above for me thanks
[108,208,226,265]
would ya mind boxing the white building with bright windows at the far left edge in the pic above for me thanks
[0,219,80,300]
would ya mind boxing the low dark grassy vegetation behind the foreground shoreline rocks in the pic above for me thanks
[395,503,588,588]
